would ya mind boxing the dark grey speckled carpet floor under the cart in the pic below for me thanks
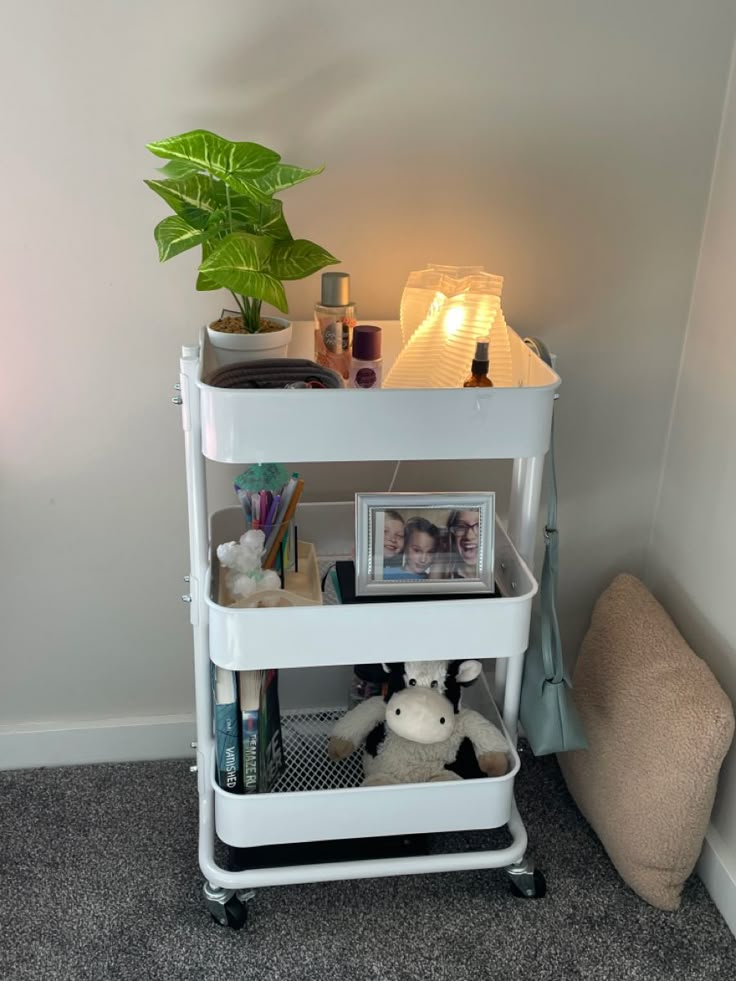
[0,752,736,981]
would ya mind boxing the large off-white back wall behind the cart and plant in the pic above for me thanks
[0,0,734,766]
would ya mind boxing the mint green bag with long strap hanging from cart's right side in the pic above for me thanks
[519,338,588,756]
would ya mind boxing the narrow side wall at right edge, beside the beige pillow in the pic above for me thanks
[646,40,736,931]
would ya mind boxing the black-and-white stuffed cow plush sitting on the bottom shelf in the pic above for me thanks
[327,661,509,786]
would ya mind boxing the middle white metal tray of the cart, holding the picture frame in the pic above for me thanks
[205,502,537,670]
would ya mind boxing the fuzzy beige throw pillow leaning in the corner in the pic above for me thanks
[558,575,734,910]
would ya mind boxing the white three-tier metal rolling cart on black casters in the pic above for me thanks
[174,322,560,927]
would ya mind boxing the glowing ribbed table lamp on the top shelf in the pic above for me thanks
[383,265,513,388]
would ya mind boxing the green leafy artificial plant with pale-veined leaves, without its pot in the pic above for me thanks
[145,129,340,334]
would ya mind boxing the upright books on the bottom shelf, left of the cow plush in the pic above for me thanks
[211,664,285,794]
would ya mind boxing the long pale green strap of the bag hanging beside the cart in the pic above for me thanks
[524,337,566,684]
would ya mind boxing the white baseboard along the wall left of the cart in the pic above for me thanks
[0,715,195,770]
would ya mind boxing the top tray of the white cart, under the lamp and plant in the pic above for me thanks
[182,321,560,464]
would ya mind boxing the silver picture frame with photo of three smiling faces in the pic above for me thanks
[355,491,496,596]
